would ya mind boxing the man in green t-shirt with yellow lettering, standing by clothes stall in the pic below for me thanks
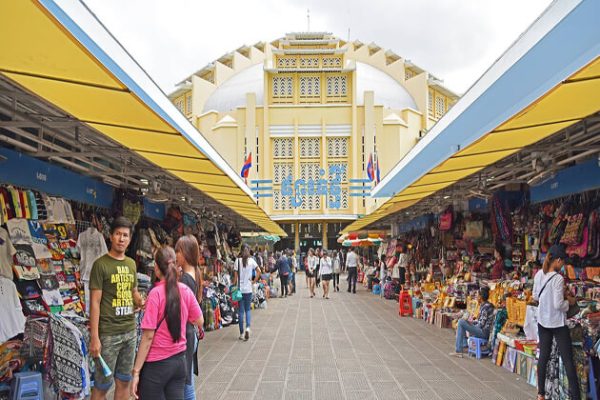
[90,217,143,400]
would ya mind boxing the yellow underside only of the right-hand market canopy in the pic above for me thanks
[343,58,600,233]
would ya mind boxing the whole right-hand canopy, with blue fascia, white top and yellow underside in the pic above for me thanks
[343,0,600,232]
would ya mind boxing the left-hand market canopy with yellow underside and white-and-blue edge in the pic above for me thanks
[0,0,286,236]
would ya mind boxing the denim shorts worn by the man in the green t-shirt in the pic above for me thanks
[94,331,137,391]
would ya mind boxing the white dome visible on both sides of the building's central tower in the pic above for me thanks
[203,62,417,112]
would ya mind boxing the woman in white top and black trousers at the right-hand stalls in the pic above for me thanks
[533,245,581,400]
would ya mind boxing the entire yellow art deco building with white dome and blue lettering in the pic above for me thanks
[170,32,457,251]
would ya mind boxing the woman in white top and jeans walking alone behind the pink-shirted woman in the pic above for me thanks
[234,244,260,341]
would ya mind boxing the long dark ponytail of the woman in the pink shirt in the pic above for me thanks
[154,246,181,342]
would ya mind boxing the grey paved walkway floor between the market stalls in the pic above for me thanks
[196,276,535,400]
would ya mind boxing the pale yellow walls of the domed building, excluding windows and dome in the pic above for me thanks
[171,35,455,231]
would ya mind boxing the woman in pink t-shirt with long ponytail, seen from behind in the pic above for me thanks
[131,247,204,400]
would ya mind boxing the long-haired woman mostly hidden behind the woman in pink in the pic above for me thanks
[175,235,202,400]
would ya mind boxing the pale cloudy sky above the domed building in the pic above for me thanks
[84,0,551,94]
